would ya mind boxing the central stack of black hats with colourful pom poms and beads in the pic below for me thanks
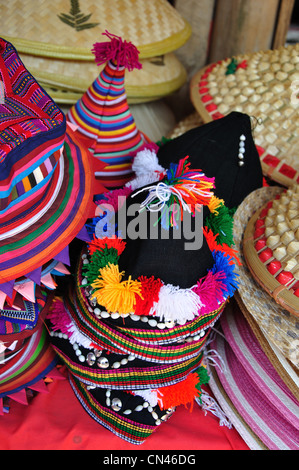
[48,158,241,444]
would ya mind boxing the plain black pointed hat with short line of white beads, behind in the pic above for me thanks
[158,112,263,208]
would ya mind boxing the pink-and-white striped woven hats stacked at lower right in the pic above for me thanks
[210,302,299,450]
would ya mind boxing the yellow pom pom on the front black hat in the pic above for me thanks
[91,263,142,313]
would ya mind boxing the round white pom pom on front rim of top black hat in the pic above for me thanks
[149,284,203,324]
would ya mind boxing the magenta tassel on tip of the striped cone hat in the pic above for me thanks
[92,30,142,71]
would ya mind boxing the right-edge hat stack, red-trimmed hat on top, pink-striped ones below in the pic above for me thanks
[206,187,299,450]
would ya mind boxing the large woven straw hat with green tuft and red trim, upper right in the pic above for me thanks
[190,43,299,187]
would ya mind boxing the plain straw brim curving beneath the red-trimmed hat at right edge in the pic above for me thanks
[234,186,299,368]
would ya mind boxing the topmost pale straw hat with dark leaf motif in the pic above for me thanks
[0,0,191,60]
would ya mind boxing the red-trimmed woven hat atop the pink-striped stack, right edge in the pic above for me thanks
[243,185,299,317]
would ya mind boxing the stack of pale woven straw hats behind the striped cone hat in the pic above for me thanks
[0,0,191,104]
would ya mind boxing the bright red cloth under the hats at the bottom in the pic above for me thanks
[0,368,248,451]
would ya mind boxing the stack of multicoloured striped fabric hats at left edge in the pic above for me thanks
[0,39,104,412]
